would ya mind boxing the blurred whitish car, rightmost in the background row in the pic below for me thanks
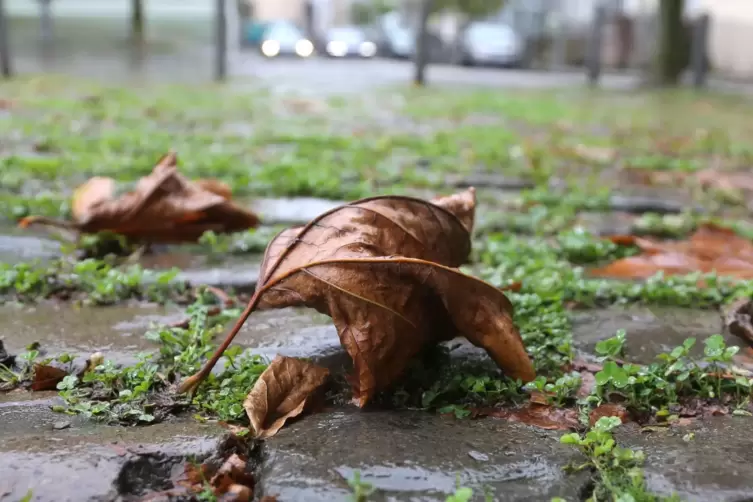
[459,21,525,67]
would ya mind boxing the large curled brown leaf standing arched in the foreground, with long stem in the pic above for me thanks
[181,189,535,406]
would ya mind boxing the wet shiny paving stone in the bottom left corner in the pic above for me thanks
[0,396,223,502]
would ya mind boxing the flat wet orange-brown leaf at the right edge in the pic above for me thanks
[589,224,753,279]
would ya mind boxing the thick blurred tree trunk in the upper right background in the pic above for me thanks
[656,0,687,86]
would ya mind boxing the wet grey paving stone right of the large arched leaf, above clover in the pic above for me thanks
[572,307,742,363]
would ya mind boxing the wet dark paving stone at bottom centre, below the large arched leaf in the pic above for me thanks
[260,411,584,502]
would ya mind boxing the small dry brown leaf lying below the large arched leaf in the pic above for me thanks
[243,356,329,439]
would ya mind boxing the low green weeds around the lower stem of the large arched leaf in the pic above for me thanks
[54,302,267,423]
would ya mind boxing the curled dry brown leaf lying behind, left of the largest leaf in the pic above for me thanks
[19,153,259,243]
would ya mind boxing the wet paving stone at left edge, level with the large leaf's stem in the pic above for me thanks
[0,304,183,363]
